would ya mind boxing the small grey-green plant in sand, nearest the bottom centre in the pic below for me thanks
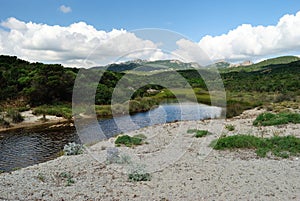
[128,164,151,182]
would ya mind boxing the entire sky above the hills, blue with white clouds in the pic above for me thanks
[0,0,300,67]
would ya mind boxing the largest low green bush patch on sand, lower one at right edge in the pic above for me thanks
[211,135,300,158]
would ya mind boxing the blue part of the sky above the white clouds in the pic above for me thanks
[0,0,300,66]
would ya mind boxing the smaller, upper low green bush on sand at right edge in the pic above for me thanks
[253,112,300,126]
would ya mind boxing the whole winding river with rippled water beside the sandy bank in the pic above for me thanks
[0,104,221,171]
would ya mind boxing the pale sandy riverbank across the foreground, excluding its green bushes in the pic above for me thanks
[0,109,300,201]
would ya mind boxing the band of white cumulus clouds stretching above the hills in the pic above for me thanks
[0,9,300,67]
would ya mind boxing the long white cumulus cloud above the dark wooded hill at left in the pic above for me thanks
[0,18,163,67]
